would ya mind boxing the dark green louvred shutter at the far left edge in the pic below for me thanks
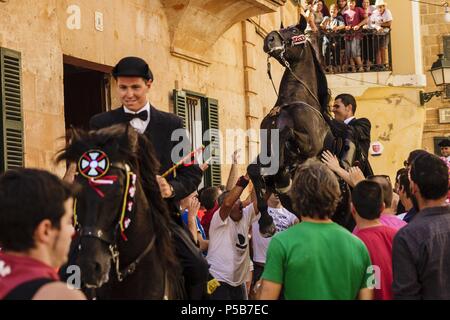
[0,48,24,172]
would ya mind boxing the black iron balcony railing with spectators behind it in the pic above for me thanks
[309,29,392,74]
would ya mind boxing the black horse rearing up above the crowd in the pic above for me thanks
[247,16,354,236]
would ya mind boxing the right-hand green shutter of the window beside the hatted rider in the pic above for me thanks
[202,98,222,186]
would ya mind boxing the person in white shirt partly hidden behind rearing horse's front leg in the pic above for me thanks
[252,194,299,285]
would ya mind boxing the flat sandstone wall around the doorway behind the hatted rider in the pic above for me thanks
[0,0,296,180]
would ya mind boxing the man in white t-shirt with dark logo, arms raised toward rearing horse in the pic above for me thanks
[206,176,259,300]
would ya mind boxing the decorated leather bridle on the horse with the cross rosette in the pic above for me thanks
[74,162,156,282]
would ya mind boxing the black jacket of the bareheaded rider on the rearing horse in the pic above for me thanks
[348,118,373,177]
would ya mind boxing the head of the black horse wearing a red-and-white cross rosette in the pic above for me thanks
[58,125,142,287]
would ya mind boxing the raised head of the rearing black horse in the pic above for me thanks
[264,16,307,66]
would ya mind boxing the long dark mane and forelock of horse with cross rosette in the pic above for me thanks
[56,124,178,286]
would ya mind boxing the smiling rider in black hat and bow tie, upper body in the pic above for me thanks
[90,57,202,201]
